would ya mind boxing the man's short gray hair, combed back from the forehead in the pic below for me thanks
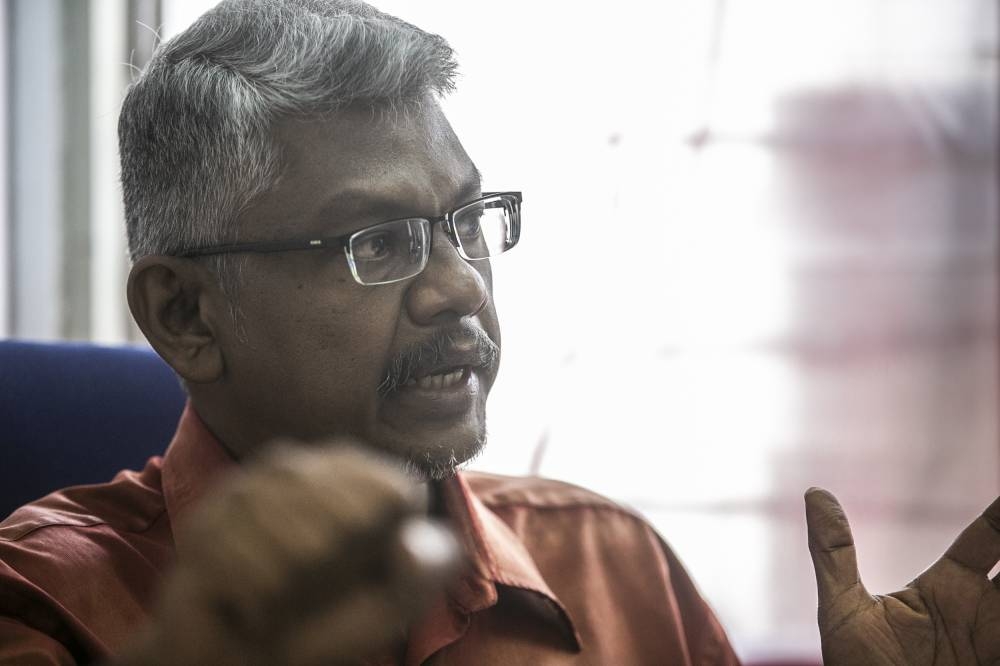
[118,0,456,270]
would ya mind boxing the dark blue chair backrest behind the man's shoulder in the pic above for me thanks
[0,340,185,519]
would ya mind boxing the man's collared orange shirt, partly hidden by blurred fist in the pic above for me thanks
[0,406,738,666]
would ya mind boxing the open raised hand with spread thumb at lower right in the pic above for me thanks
[806,488,1000,666]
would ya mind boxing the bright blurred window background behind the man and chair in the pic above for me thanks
[0,0,1000,659]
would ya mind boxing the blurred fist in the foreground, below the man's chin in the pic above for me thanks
[116,445,458,666]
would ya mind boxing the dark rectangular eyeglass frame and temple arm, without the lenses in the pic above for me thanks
[176,192,521,287]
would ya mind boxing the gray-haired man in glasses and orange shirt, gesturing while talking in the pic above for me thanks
[0,0,1000,664]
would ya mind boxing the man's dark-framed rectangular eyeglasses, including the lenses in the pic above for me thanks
[180,192,521,286]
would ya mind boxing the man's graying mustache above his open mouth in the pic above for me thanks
[376,323,500,398]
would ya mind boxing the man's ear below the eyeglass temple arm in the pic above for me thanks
[127,256,228,384]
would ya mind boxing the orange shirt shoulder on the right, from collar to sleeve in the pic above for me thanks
[463,472,737,664]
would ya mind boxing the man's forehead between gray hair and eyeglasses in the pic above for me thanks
[257,104,479,232]
